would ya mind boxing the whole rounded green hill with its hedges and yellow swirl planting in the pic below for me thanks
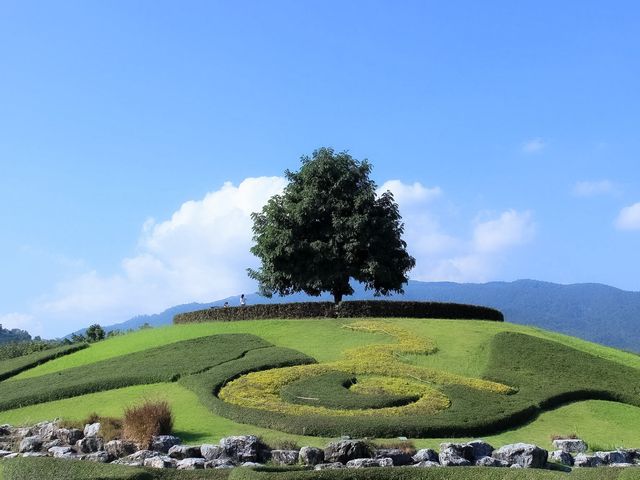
[0,319,640,448]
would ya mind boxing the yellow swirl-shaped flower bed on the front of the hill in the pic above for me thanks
[219,321,514,416]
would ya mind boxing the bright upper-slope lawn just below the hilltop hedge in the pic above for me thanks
[10,319,640,381]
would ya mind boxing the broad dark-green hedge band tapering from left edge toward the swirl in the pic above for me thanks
[0,334,271,410]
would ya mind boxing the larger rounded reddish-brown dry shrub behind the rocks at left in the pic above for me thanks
[122,400,173,448]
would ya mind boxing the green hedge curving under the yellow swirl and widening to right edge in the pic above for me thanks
[181,333,640,438]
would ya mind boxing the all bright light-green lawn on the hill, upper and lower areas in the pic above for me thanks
[0,319,640,447]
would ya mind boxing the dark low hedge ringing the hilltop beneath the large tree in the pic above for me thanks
[173,300,504,323]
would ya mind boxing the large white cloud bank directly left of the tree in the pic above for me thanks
[35,177,286,335]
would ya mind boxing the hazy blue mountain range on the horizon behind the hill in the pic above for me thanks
[87,280,640,353]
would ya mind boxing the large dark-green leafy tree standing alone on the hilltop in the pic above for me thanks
[247,148,415,303]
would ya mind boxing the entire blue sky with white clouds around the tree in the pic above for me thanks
[0,0,640,336]
